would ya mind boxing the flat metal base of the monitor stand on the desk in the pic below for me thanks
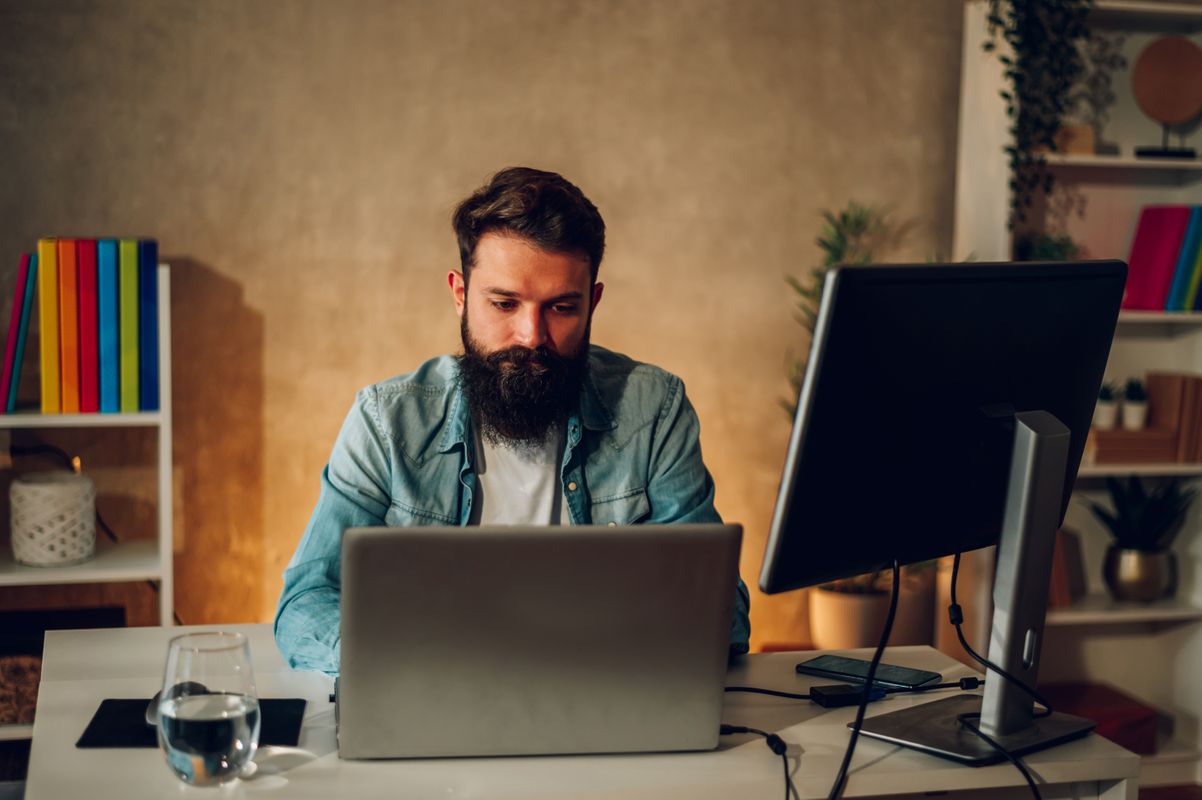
[849,679,1094,766]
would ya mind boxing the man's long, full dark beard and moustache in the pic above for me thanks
[459,310,589,447]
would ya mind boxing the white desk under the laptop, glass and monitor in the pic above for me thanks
[25,625,1139,800]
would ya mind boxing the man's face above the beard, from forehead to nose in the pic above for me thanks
[447,232,605,358]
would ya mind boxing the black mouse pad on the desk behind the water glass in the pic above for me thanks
[76,698,304,747]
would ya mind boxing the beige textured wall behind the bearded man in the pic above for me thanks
[0,0,960,643]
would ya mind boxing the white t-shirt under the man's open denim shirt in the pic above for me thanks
[470,428,572,525]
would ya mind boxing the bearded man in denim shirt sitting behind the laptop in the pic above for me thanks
[275,167,750,674]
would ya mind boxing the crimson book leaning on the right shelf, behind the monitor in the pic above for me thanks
[1123,205,1192,311]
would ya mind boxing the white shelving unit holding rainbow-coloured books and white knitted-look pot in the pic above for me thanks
[0,264,174,619]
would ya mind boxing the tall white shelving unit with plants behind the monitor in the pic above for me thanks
[953,0,1202,786]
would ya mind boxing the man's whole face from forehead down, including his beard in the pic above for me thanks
[447,227,602,446]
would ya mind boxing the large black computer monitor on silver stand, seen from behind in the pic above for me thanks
[760,261,1126,763]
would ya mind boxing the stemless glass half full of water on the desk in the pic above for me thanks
[159,632,260,786]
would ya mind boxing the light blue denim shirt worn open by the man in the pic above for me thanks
[275,346,750,675]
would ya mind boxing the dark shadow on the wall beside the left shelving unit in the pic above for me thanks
[163,257,264,625]
